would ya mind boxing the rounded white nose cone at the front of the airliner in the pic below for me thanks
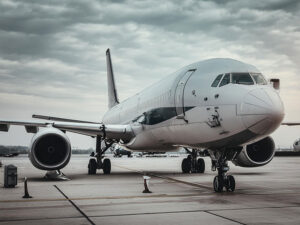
[240,87,284,135]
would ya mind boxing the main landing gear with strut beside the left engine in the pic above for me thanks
[88,136,113,174]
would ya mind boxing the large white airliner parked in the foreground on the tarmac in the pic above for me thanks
[0,49,284,192]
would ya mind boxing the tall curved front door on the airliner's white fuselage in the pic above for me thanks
[175,69,196,119]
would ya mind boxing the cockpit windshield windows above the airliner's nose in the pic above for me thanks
[211,73,267,87]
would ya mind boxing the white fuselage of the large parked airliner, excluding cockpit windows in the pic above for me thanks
[103,59,284,151]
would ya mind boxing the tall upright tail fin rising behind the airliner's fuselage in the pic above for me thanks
[106,48,119,108]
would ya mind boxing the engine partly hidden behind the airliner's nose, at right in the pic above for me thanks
[232,137,275,167]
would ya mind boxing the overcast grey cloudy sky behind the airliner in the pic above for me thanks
[0,0,300,147]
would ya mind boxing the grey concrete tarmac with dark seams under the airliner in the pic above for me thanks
[0,155,300,225]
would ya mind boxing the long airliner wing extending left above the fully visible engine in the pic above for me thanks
[0,120,134,141]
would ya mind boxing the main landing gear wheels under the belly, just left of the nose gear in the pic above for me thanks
[181,149,205,173]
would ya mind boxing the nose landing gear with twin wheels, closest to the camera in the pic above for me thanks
[210,150,237,192]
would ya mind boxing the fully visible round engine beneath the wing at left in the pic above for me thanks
[29,127,72,170]
